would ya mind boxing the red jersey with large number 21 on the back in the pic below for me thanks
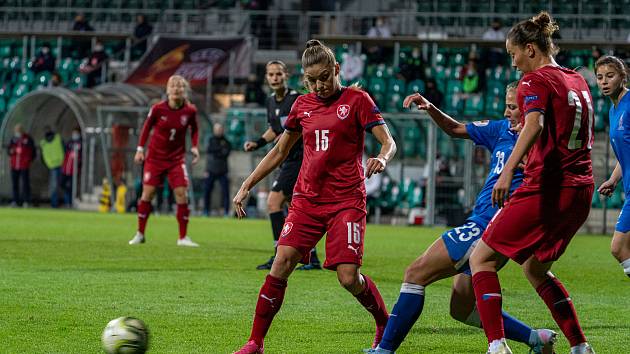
[517,66,594,189]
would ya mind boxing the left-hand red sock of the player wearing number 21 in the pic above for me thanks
[472,272,505,343]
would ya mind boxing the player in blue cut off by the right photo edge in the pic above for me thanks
[595,56,630,277]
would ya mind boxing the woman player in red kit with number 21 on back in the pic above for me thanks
[470,12,594,354]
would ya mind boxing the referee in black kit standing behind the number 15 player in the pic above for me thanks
[244,60,322,270]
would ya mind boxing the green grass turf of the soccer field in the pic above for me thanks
[0,209,630,354]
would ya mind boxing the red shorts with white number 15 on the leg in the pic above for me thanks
[278,198,366,270]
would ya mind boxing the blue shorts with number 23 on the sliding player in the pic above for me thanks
[442,221,486,275]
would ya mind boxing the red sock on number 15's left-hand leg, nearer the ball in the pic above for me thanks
[249,274,287,345]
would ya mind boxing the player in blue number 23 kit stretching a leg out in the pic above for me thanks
[368,83,556,354]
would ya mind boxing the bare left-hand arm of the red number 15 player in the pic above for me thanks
[232,130,302,218]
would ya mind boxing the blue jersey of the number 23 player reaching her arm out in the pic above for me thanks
[466,119,523,229]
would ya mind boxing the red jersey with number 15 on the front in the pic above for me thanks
[285,88,385,203]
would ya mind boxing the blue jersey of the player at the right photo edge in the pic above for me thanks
[609,92,630,199]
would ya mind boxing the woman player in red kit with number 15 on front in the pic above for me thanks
[234,40,396,354]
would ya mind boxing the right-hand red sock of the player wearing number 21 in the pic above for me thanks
[536,276,586,347]
